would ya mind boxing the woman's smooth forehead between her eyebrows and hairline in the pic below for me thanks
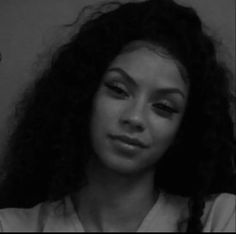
[109,47,186,89]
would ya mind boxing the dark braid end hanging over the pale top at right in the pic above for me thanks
[187,196,205,232]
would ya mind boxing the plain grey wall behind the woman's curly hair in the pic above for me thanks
[0,0,235,159]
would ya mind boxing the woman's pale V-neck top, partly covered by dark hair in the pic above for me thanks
[0,193,236,232]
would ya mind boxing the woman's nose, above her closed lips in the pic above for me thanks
[119,98,146,132]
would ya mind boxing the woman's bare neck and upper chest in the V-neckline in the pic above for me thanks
[75,157,157,232]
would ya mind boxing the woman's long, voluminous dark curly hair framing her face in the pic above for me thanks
[1,0,236,231]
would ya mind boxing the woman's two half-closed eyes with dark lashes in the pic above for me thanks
[105,82,179,114]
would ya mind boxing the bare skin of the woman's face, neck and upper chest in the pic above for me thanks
[73,44,188,232]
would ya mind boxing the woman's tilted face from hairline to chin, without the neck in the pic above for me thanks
[90,47,188,173]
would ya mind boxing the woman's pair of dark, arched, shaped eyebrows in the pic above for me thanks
[107,67,185,99]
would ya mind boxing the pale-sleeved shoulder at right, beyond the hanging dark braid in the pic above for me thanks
[202,193,236,232]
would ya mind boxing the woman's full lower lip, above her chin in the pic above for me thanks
[111,138,142,154]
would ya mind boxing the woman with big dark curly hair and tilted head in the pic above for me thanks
[0,0,235,232]
